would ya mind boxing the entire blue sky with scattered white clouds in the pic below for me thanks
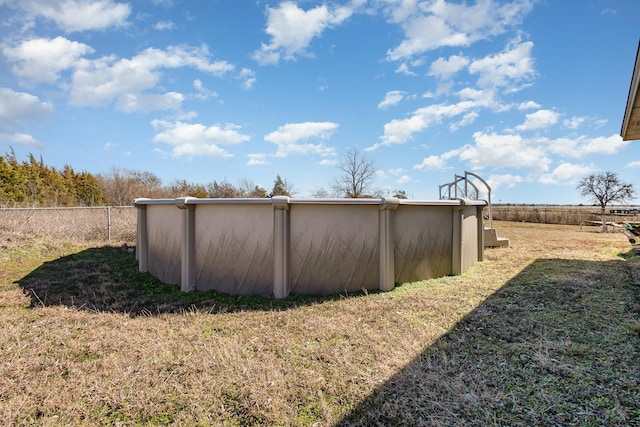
[0,0,640,204]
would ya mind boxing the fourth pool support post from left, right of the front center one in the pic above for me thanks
[378,197,400,291]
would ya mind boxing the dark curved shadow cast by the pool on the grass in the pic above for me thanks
[16,246,362,316]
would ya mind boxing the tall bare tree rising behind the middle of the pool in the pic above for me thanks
[333,148,379,198]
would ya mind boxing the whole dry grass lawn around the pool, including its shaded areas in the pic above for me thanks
[0,222,640,426]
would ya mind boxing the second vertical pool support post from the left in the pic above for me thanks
[176,197,196,292]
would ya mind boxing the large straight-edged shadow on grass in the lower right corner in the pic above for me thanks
[338,251,640,426]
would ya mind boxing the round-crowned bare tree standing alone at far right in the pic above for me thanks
[577,172,636,230]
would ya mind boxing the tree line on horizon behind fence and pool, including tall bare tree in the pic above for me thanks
[0,149,398,207]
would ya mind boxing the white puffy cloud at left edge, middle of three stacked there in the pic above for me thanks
[2,36,94,83]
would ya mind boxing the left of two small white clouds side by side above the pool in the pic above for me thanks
[151,120,251,158]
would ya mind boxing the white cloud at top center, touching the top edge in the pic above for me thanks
[253,1,353,64]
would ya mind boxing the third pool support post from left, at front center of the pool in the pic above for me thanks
[271,196,289,299]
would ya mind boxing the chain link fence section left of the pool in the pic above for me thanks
[0,206,137,245]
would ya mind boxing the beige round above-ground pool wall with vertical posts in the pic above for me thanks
[134,197,486,298]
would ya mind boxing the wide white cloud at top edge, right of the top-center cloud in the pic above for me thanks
[387,0,532,61]
